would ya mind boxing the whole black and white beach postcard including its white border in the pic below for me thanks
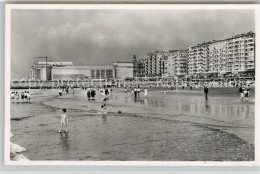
[5,4,259,165]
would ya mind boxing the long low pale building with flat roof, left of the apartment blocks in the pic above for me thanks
[29,62,133,81]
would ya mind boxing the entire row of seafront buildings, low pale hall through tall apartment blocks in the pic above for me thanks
[29,32,255,81]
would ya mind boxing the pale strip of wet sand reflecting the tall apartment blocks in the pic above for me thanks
[108,94,254,121]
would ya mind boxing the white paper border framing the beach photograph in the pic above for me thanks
[4,4,260,166]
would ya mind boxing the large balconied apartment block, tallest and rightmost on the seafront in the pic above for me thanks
[188,32,255,76]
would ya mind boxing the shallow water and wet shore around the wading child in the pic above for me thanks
[11,90,254,161]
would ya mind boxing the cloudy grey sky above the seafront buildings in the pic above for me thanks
[11,9,255,79]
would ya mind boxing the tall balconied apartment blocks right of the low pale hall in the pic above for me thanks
[133,32,255,77]
